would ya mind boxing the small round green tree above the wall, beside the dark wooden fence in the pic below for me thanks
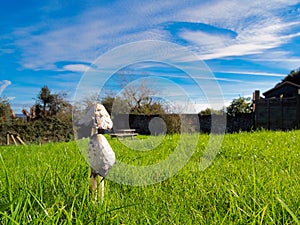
[227,97,252,116]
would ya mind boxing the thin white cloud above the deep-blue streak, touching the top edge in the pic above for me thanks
[179,0,299,28]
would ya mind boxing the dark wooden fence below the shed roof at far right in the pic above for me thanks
[253,91,300,130]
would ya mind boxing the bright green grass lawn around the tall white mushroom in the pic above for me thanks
[0,131,300,224]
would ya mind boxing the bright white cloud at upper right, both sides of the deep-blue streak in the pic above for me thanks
[172,1,300,59]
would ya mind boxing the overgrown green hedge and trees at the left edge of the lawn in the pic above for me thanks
[0,86,73,145]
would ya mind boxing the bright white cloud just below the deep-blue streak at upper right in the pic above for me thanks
[183,20,300,59]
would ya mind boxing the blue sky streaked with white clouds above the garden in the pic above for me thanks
[0,0,300,113]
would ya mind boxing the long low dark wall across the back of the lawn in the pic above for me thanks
[112,113,253,134]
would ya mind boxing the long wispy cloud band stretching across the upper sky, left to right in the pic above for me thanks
[8,1,300,70]
